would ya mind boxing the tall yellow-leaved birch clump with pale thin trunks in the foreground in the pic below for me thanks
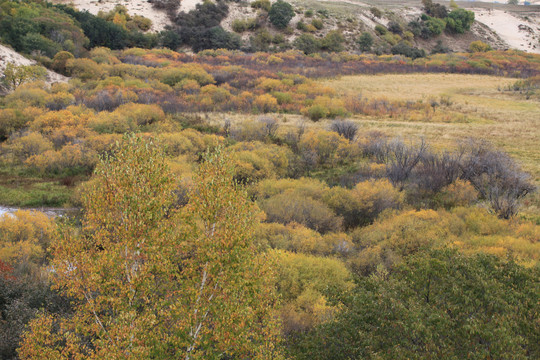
[19,136,279,359]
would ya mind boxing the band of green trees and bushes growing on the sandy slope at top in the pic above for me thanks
[0,0,490,57]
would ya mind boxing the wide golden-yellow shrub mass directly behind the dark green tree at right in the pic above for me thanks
[351,208,540,274]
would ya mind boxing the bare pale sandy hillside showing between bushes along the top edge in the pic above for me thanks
[49,0,540,53]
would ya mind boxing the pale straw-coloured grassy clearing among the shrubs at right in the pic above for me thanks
[325,74,540,182]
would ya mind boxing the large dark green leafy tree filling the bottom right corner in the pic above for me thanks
[293,250,540,359]
